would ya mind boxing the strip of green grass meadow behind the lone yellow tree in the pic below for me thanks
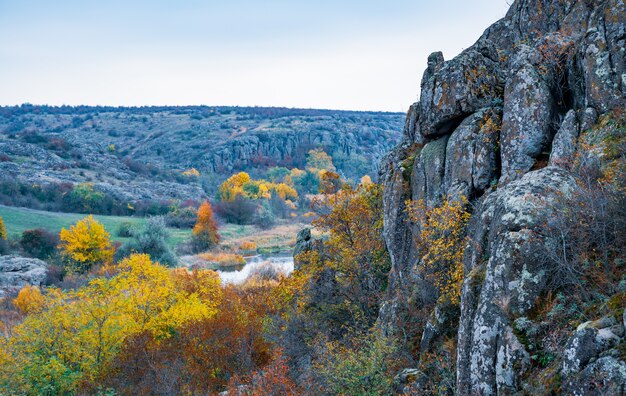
[0,205,191,246]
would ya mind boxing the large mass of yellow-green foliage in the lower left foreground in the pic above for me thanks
[0,254,222,394]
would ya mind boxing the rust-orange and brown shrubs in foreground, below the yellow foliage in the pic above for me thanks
[99,284,281,395]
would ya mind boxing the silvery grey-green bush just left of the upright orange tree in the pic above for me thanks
[116,216,178,267]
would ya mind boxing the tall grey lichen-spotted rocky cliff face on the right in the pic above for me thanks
[379,0,626,395]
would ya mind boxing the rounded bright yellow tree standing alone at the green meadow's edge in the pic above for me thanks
[59,215,114,272]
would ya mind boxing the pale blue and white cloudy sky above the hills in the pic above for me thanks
[0,0,510,112]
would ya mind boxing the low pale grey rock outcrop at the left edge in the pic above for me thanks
[0,256,48,297]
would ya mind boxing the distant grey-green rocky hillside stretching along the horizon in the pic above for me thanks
[0,105,402,206]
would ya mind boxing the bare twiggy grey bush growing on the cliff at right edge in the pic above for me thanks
[538,169,626,297]
